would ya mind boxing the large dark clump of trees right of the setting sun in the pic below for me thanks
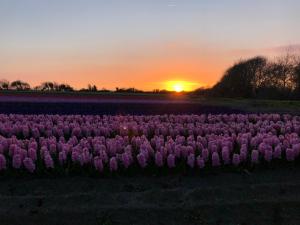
[195,54,300,99]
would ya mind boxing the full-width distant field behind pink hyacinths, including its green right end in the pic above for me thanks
[0,91,300,114]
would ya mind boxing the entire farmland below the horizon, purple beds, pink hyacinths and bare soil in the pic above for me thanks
[0,93,300,225]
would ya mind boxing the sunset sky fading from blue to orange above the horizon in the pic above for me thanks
[0,0,300,90]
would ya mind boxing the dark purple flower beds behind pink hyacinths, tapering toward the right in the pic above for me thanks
[0,92,240,115]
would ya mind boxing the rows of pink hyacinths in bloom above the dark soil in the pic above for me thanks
[0,114,300,174]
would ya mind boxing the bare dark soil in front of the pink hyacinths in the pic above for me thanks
[0,166,300,225]
